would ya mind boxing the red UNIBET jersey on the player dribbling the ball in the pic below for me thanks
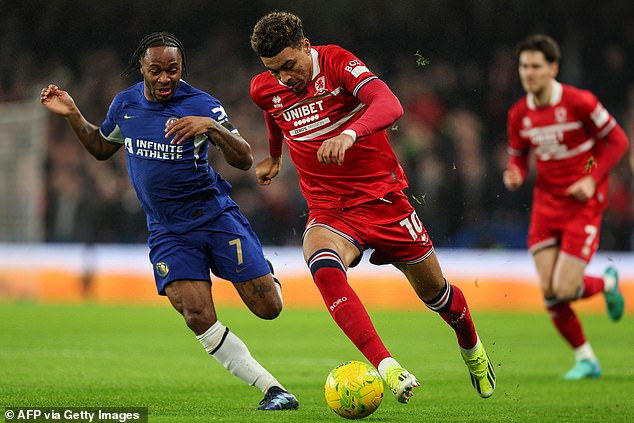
[251,45,407,209]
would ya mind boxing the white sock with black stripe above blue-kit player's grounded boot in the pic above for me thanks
[196,321,284,392]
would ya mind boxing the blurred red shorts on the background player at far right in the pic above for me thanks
[528,198,603,263]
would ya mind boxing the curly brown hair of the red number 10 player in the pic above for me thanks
[251,12,304,57]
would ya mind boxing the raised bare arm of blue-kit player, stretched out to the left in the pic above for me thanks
[40,84,121,160]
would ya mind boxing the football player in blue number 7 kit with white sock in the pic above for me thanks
[40,32,298,410]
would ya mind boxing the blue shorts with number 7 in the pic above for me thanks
[148,208,270,295]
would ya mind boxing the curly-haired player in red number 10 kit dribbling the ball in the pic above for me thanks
[251,12,495,403]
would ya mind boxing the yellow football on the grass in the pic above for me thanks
[324,361,383,419]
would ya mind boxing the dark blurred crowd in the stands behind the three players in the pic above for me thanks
[0,0,634,250]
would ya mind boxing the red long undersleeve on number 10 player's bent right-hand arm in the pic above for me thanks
[346,78,403,137]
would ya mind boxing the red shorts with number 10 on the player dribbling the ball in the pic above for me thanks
[304,192,434,264]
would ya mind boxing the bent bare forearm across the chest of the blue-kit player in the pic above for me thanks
[165,116,253,170]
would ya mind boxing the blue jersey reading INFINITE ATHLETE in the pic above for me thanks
[100,80,237,233]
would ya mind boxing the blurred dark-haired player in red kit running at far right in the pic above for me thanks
[503,34,629,380]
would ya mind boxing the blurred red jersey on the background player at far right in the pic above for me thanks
[508,81,616,212]
